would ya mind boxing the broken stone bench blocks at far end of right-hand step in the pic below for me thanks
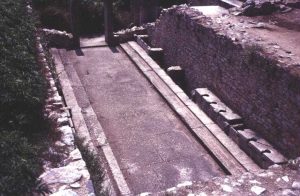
[134,34,164,65]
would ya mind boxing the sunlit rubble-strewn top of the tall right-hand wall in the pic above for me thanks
[155,5,300,78]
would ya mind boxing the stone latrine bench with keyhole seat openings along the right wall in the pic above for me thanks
[192,88,287,168]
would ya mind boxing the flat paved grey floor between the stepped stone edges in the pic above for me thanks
[63,37,224,194]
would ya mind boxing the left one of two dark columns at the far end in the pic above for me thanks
[69,0,80,48]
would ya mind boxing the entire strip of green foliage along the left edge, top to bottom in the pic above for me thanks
[0,0,46,195]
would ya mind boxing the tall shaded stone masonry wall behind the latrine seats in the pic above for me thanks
[149,6,300,157]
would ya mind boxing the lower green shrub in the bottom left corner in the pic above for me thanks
[0,131,41,195]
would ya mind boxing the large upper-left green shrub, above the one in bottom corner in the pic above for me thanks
[0,0,45,136]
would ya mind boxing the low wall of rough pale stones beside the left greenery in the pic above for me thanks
[36,37,95,196]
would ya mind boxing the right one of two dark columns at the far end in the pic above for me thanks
[104,0,115,46]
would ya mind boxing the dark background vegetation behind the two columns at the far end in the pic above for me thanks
[32,0,186,35]
